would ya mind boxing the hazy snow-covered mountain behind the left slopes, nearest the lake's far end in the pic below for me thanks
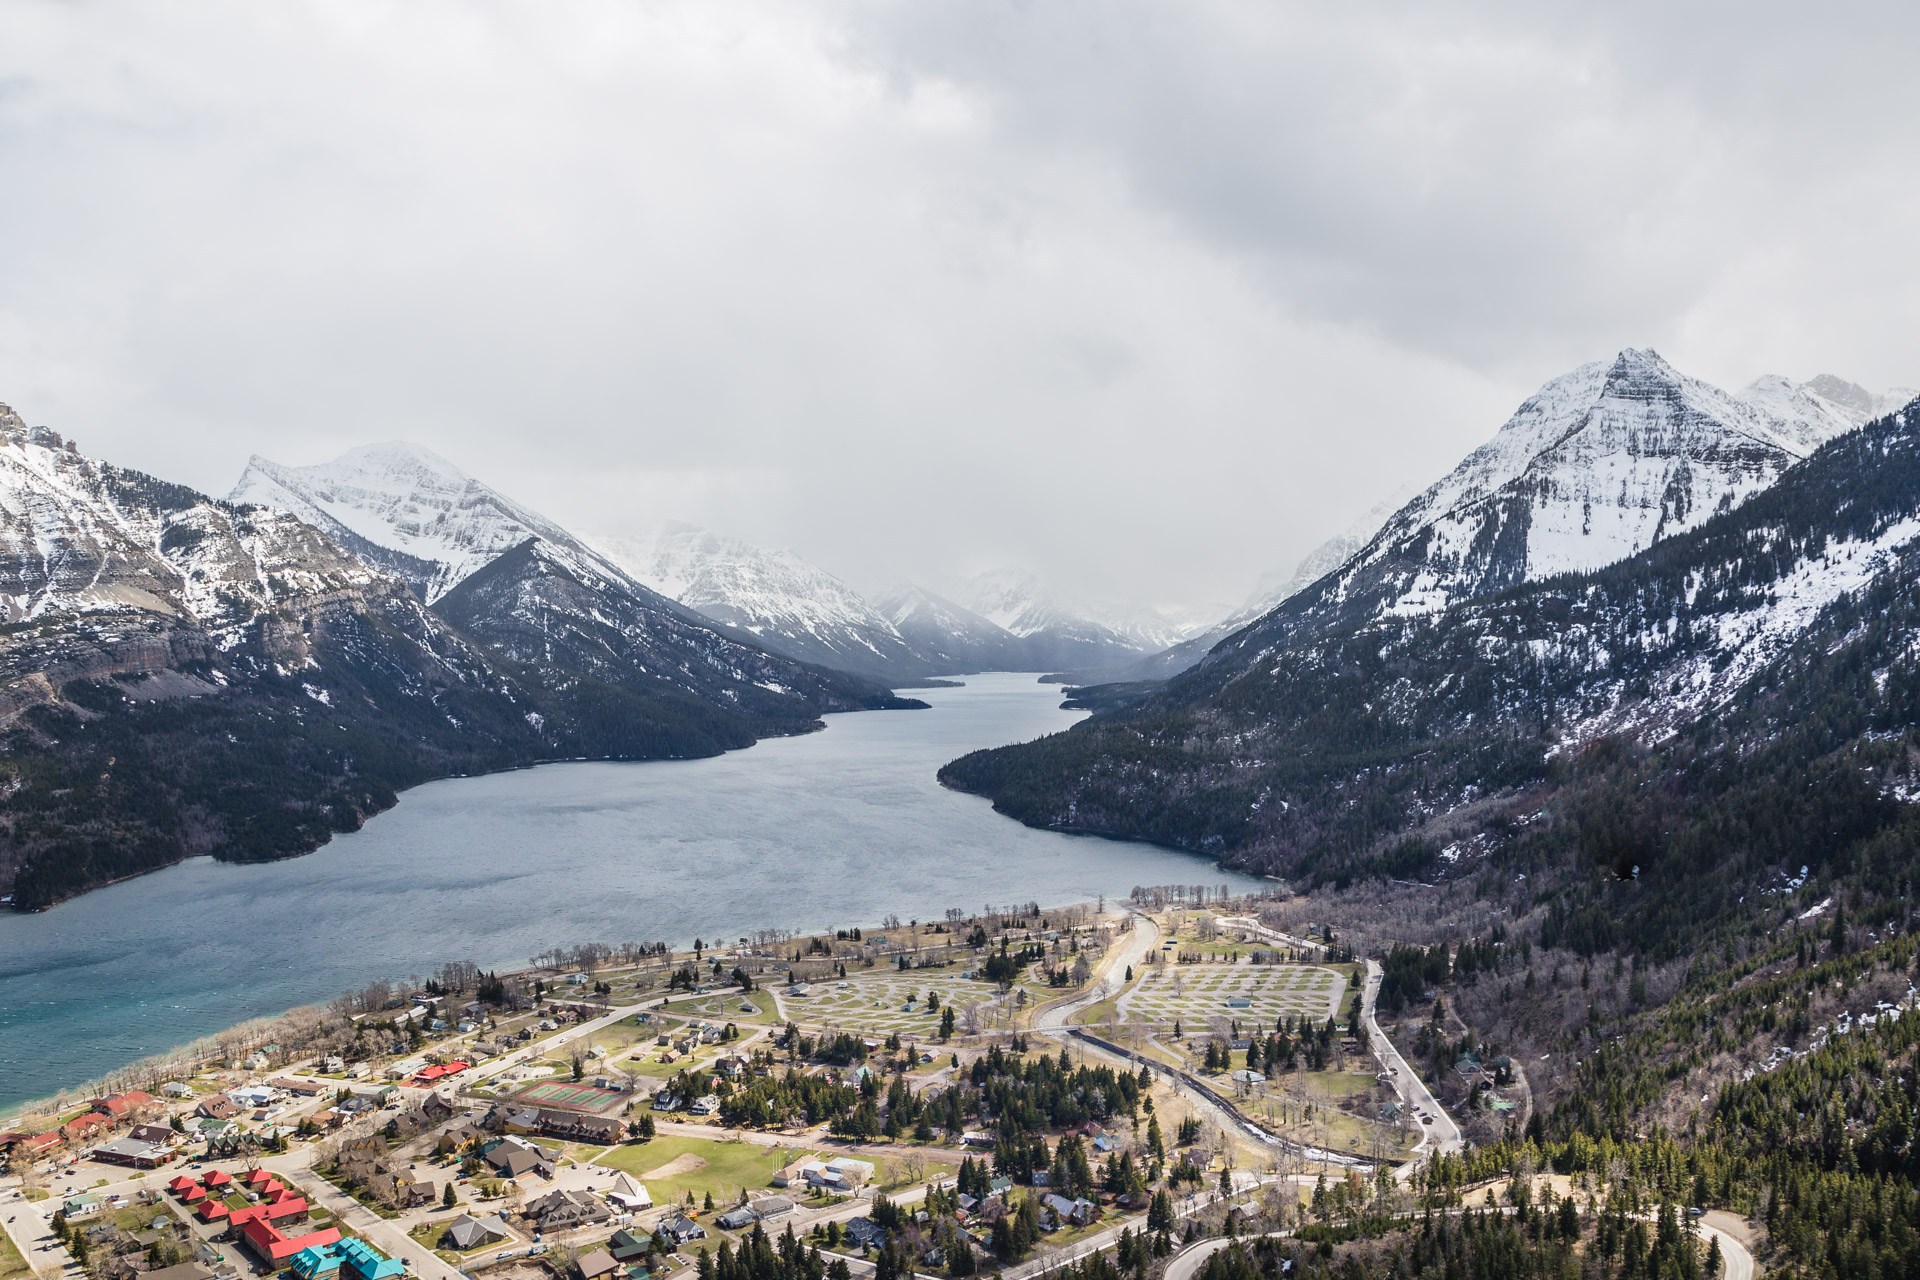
[595,522,936,679]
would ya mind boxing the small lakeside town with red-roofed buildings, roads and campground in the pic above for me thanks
[0,887,1574,1280]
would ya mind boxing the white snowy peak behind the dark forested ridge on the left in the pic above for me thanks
[227,441,622,604]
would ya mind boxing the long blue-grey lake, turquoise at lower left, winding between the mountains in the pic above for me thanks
[0,674,1258,1107]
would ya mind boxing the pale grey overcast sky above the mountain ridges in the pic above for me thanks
[0,0,1920,604]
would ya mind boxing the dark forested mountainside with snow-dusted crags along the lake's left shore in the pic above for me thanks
[0,407,908,910]
